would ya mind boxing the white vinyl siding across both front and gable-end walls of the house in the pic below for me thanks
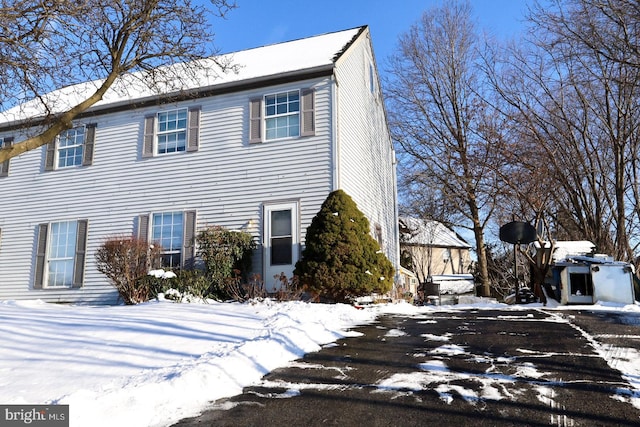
[0,26,395,303]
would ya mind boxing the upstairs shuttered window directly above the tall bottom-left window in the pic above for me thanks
[44,124,96,171]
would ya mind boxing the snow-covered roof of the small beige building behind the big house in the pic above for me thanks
[400,217,471,248]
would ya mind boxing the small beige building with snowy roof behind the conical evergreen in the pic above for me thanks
[399,217,471,283]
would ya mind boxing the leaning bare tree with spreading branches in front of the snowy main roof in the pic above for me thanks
[0,0,235,162]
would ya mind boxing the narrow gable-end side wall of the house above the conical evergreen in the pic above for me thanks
[335,31,400,271]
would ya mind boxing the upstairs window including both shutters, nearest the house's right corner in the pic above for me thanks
[249,89,315,143]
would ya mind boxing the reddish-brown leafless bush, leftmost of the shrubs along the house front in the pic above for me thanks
[95,236,162,305]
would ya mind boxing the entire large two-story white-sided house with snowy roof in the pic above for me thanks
[0,26,400,303]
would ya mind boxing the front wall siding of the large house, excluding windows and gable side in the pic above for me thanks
[0,78,333,303]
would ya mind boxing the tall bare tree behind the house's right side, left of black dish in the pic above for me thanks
[386,3,496,295]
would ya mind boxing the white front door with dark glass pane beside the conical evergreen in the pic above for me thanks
[263,202,300,292]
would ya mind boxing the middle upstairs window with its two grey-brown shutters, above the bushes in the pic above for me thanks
[142,107,200,157]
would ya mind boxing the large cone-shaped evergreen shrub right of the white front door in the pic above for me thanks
[294,190,394,302]
